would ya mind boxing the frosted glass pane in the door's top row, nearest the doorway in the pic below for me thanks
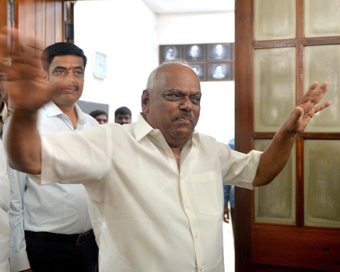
[254,0,296,41]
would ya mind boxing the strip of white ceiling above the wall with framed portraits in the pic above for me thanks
[143,0,235,14]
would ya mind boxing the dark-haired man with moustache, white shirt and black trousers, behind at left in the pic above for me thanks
[4,42,98,272]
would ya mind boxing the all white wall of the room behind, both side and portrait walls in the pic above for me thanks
[75,0,235,142]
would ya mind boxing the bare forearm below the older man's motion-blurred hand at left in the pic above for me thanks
[6,109,41,174]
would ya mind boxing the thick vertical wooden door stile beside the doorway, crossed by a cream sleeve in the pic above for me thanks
[234,0,254,272]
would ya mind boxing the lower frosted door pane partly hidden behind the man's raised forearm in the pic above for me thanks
[255,140,295,224]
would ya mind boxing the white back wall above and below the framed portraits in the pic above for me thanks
[157,12,235,143]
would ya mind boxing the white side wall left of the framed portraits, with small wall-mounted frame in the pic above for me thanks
[74,0,158,122]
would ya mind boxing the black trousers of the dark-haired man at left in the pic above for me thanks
[25,231,98,272]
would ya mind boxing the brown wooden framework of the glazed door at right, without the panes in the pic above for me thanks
[235,0,340,272]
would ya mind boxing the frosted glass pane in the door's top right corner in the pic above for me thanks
[305,0,340,37]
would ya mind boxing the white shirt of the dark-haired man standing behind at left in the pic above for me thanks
[4,102,98,272]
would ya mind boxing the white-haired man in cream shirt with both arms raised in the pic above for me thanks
[3,31,330,272]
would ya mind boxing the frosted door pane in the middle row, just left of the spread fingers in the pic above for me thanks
[254,47,296,132]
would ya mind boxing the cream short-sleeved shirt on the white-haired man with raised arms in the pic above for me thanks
[35,113,261,272]
